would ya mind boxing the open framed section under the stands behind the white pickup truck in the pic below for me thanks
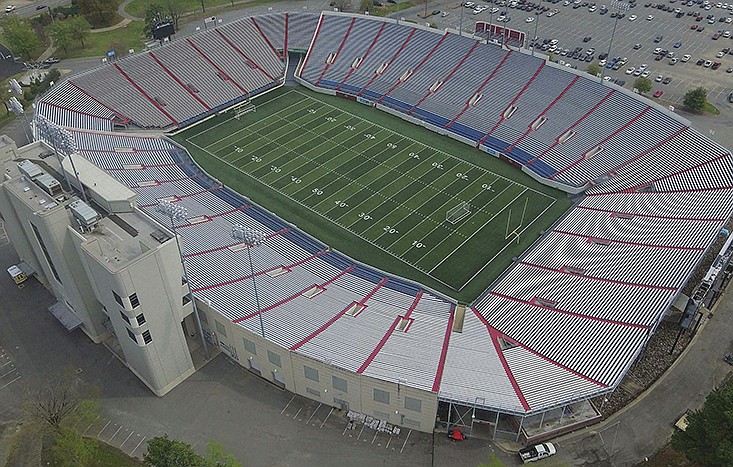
[436,399,602,445]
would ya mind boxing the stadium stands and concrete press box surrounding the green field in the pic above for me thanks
[0,13,733,440]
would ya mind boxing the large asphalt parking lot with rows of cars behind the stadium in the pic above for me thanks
[435,0,733,106]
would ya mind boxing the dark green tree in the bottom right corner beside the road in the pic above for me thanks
[672,380,733,465]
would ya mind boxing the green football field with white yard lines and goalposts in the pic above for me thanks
[174,87,570,301]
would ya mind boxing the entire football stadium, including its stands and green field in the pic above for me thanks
[8,12,733,442]
